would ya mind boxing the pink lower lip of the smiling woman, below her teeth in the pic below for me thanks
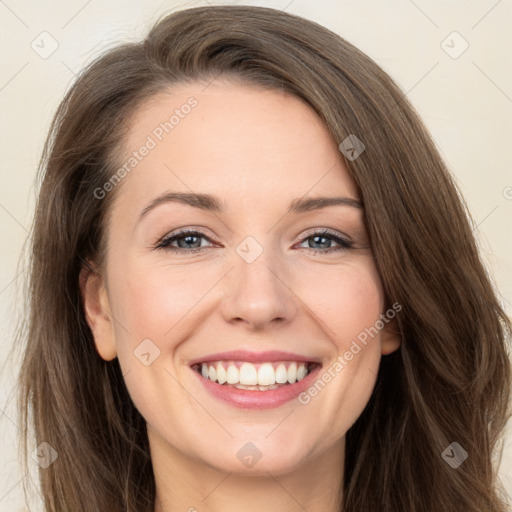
[192,366,321,409]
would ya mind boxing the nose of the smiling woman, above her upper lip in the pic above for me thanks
[221,251,298,330]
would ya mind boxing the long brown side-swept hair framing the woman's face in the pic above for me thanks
[19,6,512,512]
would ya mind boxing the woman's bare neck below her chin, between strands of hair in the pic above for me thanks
[151,432,345,512]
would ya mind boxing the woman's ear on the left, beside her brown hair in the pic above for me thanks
[79,262,117,361]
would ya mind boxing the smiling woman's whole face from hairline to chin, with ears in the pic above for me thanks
[83,81,399,475]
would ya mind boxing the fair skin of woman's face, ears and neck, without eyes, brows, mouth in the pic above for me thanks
[82,80,400,512]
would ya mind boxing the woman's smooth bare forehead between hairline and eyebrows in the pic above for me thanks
[112,81,358,215]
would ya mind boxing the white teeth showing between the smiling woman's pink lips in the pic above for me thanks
[192,361,321,391]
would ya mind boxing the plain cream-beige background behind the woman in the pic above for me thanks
[0,0,512,512]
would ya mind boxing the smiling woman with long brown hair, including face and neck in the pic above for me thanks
[20,7,511,512]
